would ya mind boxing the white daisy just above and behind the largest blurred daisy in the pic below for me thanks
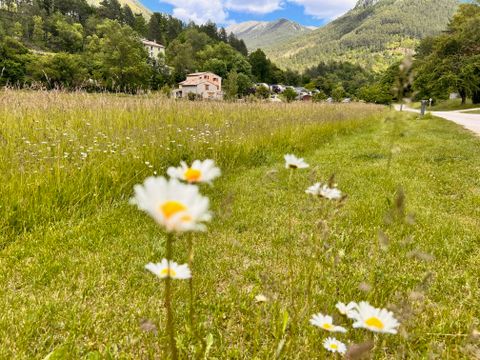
[167,160,221,184]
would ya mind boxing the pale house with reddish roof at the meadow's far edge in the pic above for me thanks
[173,72,223,100]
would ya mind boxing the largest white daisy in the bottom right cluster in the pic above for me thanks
[352,301,400,334]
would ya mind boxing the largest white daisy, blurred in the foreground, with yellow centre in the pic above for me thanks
[130,177,212,232]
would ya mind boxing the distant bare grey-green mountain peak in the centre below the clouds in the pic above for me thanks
[226,19,313,50]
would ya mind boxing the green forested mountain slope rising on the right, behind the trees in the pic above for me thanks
[264,0,460,70]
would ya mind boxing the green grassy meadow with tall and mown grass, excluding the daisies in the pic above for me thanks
[0,91,480,360]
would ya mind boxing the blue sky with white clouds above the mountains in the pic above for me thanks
[140,0,357,26]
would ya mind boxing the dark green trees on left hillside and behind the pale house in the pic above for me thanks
[0,0,388,98]
